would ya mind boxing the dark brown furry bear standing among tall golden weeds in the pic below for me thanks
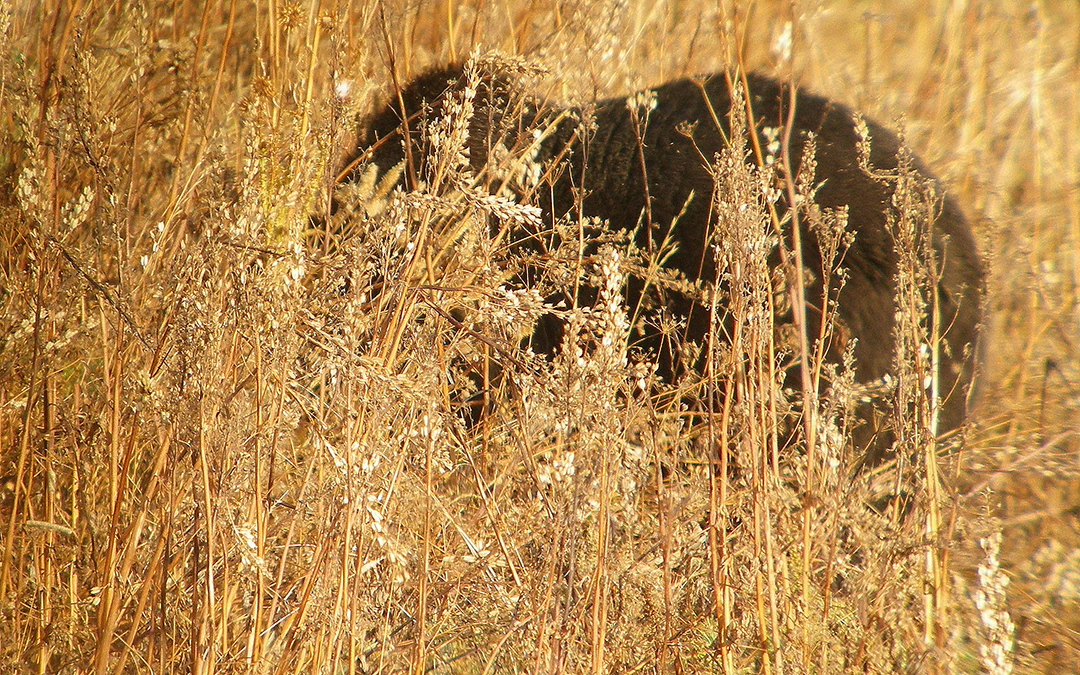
[341,61,985,463]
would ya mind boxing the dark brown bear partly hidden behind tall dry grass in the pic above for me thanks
[347,66,985,463]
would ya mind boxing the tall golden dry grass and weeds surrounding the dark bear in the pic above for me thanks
[0,0,1080,675]
